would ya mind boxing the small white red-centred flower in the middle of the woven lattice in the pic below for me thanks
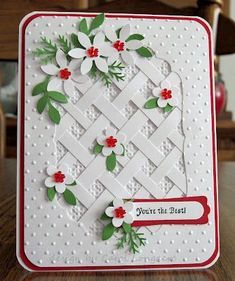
[96,127,126,156]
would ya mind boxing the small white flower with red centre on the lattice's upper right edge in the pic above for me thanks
[153,79,180,108]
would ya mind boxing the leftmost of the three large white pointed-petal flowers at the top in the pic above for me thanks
[41,49,88,96]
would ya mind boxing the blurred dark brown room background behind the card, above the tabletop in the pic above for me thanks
[0,0,235,161]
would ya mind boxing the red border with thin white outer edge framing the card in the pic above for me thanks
[17,12,219,271]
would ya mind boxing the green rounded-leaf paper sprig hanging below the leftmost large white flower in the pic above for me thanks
[32,76,68,124]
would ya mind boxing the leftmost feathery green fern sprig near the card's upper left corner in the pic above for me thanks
[32,37,58,64]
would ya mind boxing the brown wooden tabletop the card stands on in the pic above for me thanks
[0,159,235,281]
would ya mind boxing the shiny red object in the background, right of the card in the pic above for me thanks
[215,73,227,117]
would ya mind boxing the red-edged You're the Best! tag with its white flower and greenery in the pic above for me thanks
[100,196,210,254]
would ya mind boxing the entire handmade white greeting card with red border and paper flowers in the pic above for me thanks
[17,12,219,271]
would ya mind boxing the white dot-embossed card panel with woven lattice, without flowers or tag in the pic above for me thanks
[22,14,215,267]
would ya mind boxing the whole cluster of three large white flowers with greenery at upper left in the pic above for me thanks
[32,14,153,124]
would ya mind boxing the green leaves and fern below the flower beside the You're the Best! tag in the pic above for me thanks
[100,205,146,254]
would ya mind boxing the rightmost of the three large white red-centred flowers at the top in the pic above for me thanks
[105,24,142,64]
